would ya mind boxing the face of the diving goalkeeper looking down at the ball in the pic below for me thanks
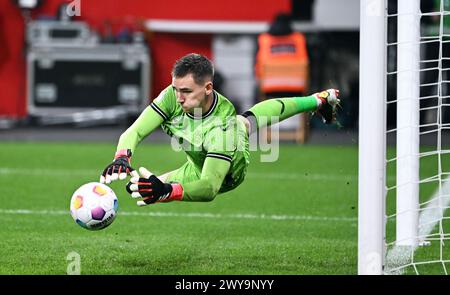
[172,74,213,113]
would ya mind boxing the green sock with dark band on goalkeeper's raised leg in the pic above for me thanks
[250,95,317,128]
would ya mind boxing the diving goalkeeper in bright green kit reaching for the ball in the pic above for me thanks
[100,54,339,206]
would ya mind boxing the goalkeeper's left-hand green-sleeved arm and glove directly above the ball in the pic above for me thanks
[100,107,163,183]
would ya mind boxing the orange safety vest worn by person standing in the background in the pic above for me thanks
[255,32,309,93]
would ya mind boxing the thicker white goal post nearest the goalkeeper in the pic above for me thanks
[358,0,386,275]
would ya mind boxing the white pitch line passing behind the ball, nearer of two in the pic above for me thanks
[0,209,357,223]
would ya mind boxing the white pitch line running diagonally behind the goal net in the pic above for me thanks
[386,178,450,274]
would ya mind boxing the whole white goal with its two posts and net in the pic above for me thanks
[358,0,450,274]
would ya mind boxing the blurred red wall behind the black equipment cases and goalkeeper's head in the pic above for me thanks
[0,0,290,118]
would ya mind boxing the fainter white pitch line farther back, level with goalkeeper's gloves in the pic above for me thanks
[0,167,358,181]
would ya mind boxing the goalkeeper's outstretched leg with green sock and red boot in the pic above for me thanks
[242,89,340,133]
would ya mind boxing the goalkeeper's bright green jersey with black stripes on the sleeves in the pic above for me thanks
[150,86,249,192]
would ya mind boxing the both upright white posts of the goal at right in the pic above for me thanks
[358,0,420,275]
